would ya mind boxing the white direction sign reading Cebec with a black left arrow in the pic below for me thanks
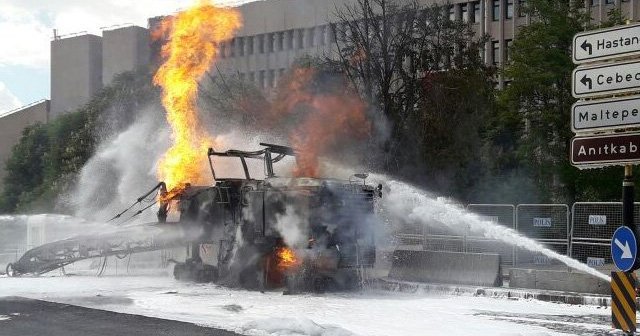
[572,60,640,98]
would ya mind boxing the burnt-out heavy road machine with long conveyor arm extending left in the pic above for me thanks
[7,144,382,292]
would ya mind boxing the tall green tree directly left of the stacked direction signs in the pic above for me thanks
[494,0,590,202]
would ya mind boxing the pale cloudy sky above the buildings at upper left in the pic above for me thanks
[0,0,255,114]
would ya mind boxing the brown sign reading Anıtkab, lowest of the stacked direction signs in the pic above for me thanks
[571,132,640,168]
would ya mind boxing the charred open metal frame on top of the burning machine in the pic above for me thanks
[207,142,295,180]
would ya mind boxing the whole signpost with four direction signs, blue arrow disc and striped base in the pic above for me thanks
[570,24,640,335]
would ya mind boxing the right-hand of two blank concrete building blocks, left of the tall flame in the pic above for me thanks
[102,26,151,86]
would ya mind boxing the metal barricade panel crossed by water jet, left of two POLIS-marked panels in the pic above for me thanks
[465,204,516,265]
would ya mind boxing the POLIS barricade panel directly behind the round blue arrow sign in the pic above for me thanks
[570,202,640,269]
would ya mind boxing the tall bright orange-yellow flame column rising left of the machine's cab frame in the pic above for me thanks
[153,0,242,190]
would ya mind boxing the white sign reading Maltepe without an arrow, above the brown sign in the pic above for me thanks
[571,96,640,132]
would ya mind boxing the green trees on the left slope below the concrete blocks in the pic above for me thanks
[0,71,159,212]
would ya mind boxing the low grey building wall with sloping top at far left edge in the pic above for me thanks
[0,100,50,190]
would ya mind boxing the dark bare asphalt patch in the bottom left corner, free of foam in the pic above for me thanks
[0,297,239,336]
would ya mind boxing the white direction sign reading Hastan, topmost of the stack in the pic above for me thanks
[573,24,640,64]
